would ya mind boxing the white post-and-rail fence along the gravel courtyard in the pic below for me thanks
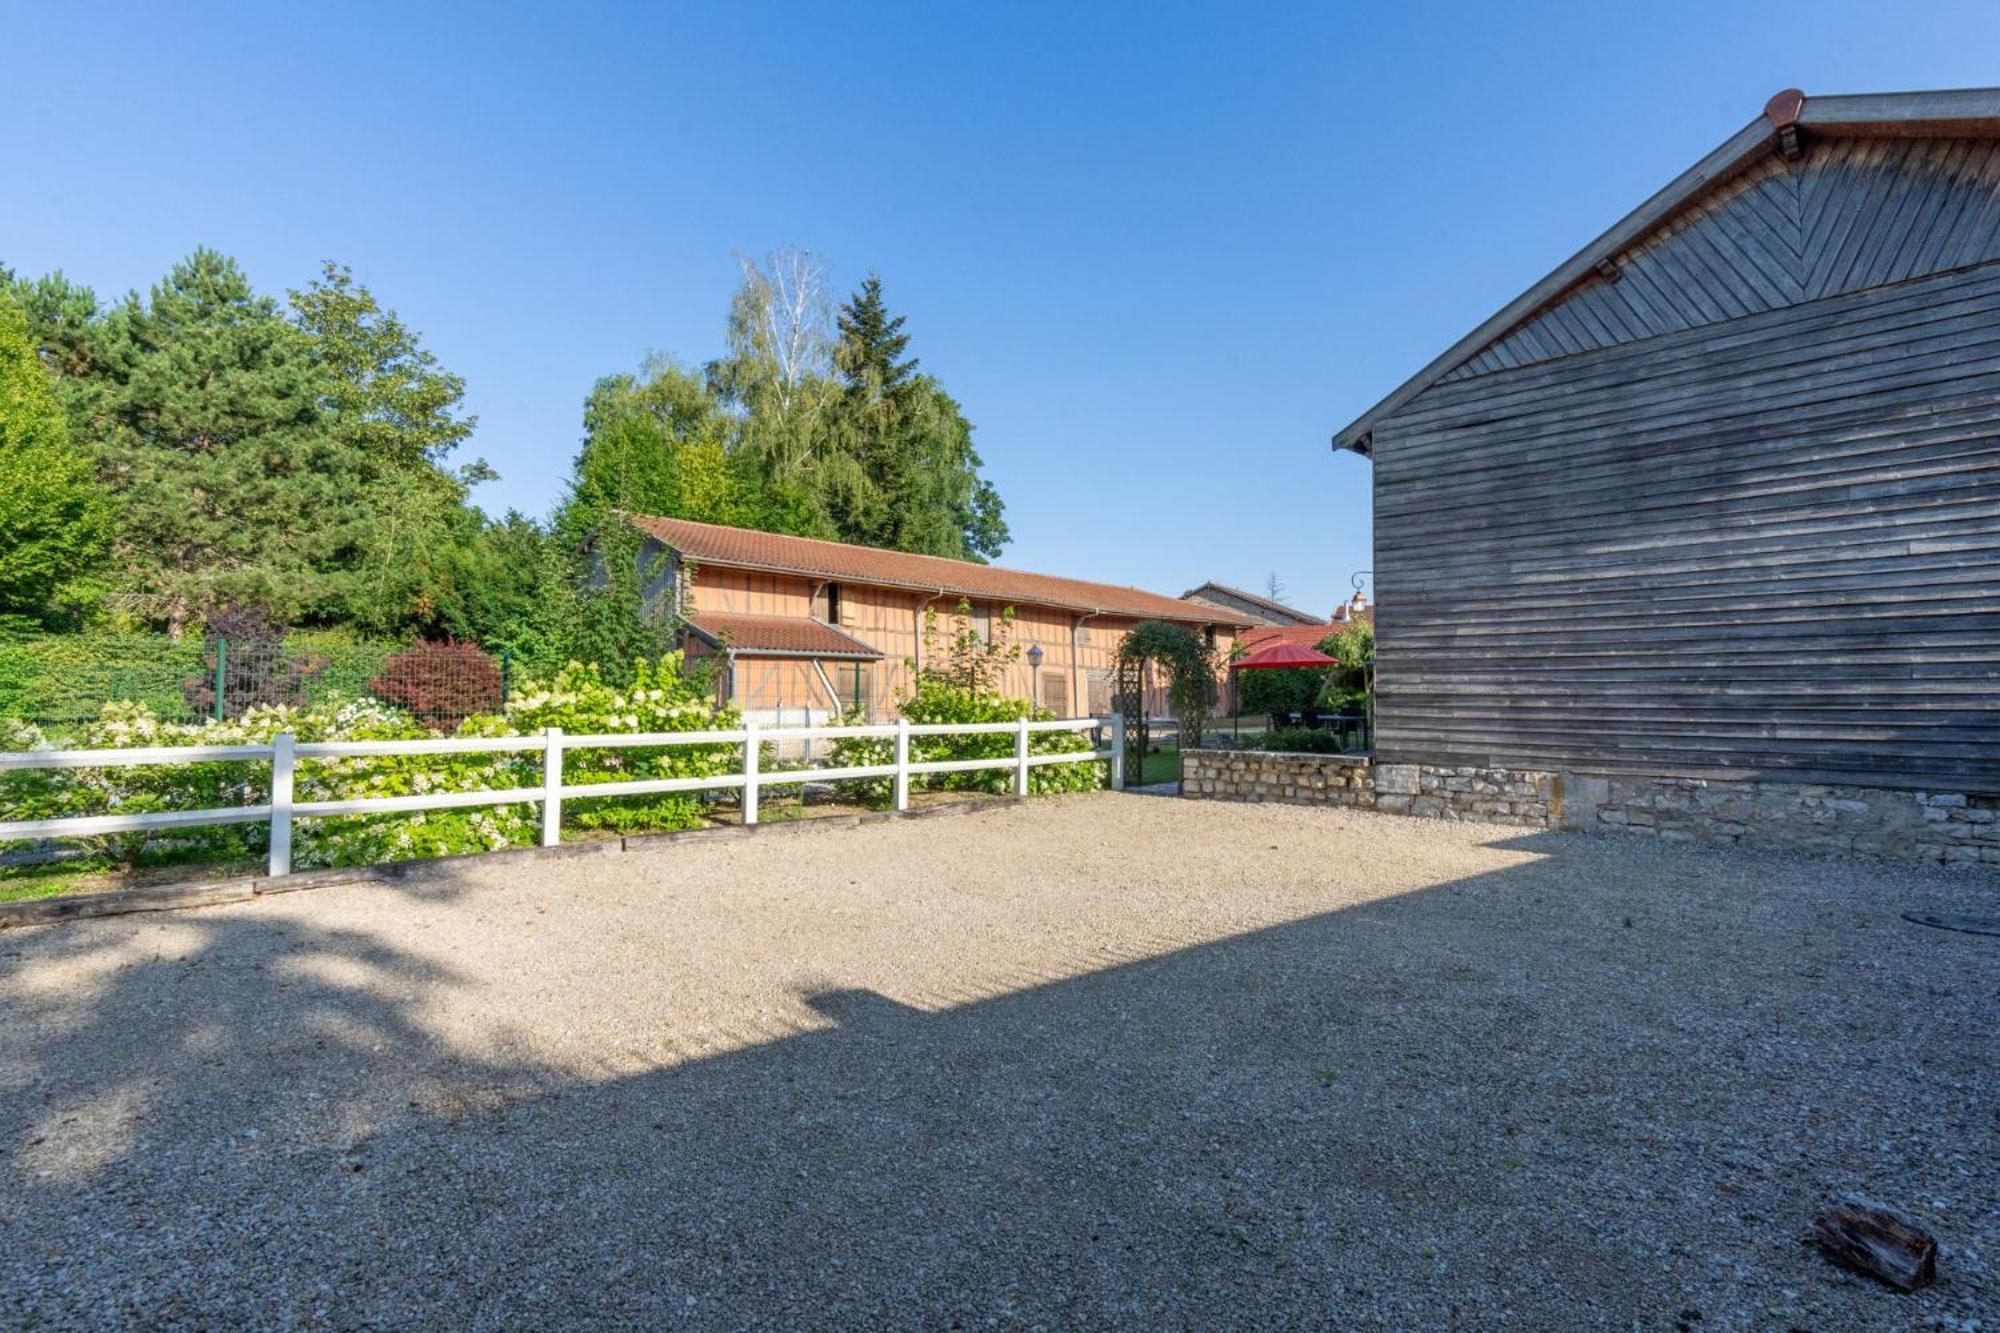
[0,717,1124,875]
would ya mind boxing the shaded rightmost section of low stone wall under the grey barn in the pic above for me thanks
[1564,775,2000,865]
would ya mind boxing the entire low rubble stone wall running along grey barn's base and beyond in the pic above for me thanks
[1182,751,2000,865]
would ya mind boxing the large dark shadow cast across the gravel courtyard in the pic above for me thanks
[0,835,2000,1329]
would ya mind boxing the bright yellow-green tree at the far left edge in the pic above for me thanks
[0,290,112,618]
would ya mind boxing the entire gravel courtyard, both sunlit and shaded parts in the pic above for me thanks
[0,795,2000,1329]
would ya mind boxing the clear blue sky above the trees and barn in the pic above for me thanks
[0,0,2000,610]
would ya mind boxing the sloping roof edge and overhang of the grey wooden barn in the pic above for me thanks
[1334,88,2000,456]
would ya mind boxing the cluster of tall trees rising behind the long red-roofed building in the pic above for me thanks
[572,252,1008,560]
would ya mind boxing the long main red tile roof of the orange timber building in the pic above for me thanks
[632,514,1250,624]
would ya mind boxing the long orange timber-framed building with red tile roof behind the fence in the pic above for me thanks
[632,516,1250,727]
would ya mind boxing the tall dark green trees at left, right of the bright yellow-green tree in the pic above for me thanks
[8,250,490,632]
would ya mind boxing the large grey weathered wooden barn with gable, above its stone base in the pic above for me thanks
[1334,90,2000,804]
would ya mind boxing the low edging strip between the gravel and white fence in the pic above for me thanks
[0,795,1036,931]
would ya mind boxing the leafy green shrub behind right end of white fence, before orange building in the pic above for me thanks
[834,673,1104,805]
